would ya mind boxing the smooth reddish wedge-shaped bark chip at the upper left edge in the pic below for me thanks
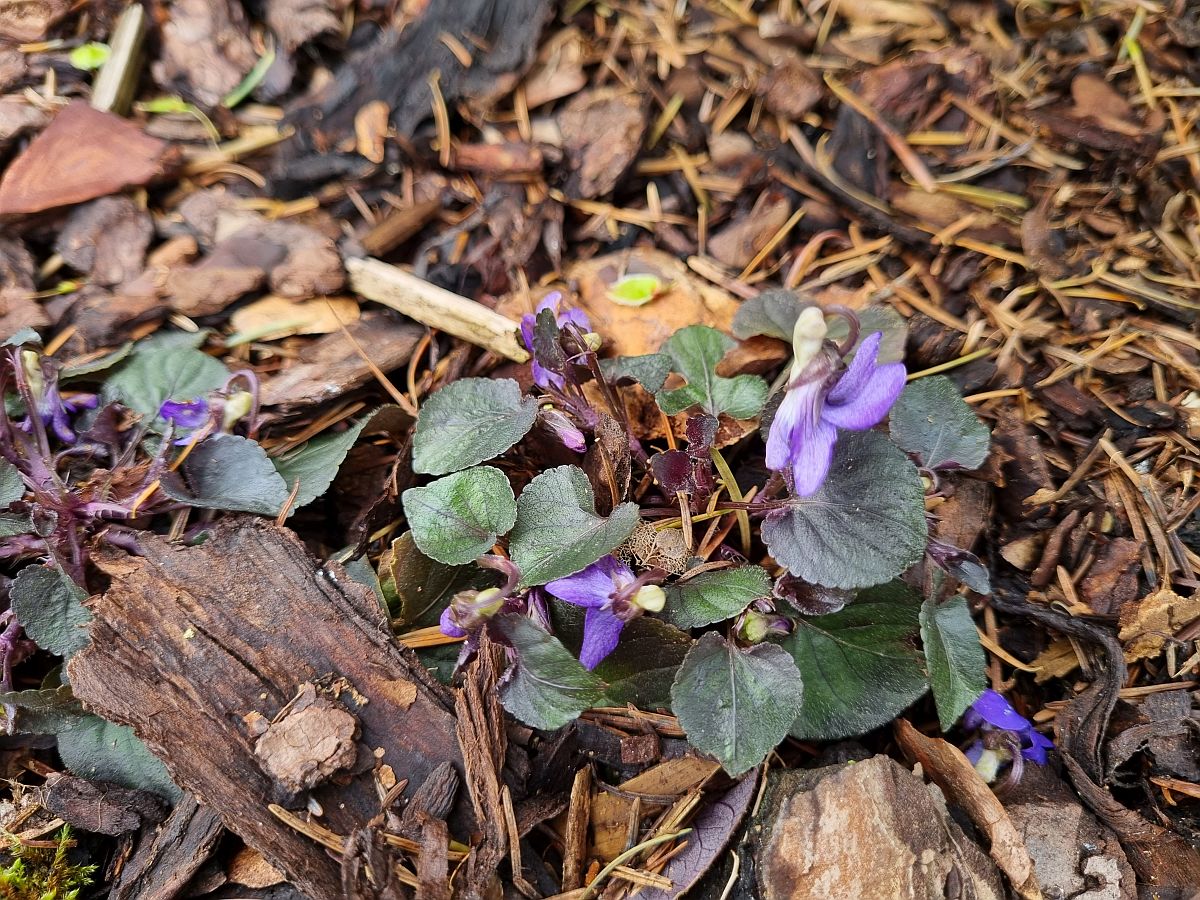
[0,101,168,216]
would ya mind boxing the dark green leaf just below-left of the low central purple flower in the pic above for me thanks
[493,614,605,731]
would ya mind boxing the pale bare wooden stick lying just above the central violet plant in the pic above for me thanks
[346,258,529,362]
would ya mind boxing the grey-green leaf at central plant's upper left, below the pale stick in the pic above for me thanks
[413,378,538,475]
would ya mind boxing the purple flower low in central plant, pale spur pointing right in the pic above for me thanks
[546,556,666,670]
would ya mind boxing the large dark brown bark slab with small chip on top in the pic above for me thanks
[70,518,469,900]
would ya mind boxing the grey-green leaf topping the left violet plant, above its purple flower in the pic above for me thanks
[101,347,229,431]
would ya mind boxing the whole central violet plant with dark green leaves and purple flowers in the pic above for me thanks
[389,294,1003,774]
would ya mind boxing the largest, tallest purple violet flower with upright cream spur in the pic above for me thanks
[767,306,907,497]
